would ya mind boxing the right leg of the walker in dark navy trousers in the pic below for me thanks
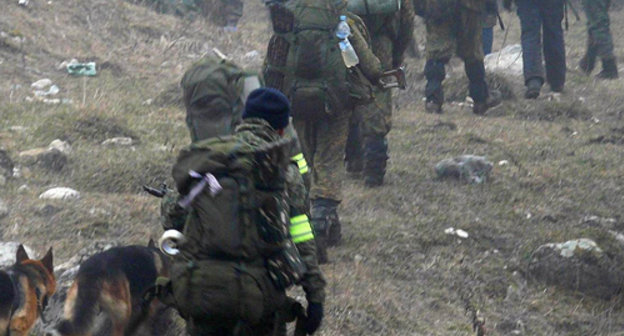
[541,0,566,92]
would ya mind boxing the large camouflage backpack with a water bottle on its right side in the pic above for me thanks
[263,0,349,118]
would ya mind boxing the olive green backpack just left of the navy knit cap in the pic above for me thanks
[180,56,259,141]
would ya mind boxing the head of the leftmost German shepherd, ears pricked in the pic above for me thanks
[14,245,56,312]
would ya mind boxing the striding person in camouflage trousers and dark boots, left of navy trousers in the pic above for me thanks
[421,0,501,114]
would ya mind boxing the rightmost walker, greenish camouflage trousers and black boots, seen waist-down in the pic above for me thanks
[579,0,618,79]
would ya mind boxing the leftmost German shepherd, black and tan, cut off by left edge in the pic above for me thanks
[0,245,56,336]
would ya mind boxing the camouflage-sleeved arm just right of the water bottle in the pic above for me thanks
[349,16,384,83]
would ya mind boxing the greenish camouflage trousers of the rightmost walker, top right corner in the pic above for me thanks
[583,0,614,59]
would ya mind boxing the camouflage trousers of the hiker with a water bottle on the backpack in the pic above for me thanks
[293,111,350,201]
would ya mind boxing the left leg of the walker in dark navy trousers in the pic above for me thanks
[516,0,550,98]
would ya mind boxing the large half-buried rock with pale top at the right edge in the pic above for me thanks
[529,238,624,299]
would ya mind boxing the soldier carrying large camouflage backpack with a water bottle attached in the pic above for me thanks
[264,0,382,262]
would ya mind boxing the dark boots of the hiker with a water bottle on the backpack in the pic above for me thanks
[311,198,342,262]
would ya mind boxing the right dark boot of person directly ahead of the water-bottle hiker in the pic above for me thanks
[364,135,388,187]
